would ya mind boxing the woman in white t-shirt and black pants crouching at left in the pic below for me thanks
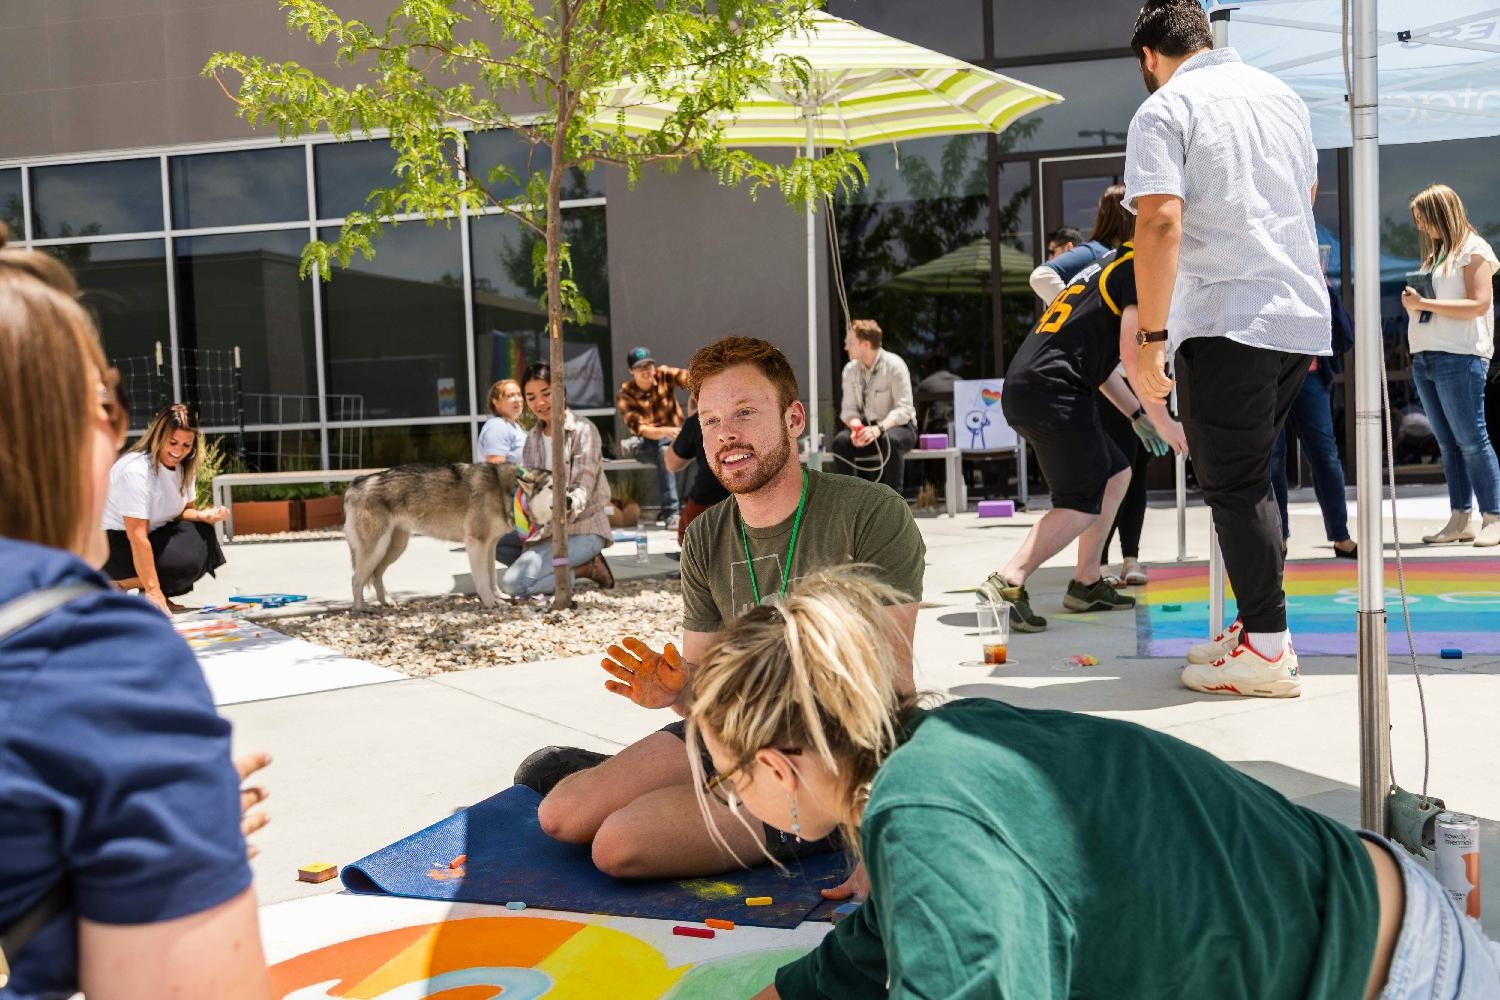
[104,403,228,613]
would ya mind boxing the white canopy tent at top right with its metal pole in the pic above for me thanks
[1203,0,1500,832]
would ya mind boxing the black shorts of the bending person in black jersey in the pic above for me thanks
[1005,390,1130,514]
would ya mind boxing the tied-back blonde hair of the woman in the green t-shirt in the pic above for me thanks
[684,567,914,864]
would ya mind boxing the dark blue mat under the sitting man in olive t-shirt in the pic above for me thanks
[342,786,848,928]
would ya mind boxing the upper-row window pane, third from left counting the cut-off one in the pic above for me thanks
[170,145,308,229]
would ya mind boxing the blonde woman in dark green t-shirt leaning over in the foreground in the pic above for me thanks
[684,568,1500,1000]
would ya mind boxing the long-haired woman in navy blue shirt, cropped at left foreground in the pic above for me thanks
[0,234,270,1000]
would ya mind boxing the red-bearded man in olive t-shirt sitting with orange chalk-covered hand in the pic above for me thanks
[528,337,926,895]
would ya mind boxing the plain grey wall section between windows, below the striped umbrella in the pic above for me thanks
[605,151,842,419]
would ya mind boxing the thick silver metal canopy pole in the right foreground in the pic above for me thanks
[1350,0,1391,834]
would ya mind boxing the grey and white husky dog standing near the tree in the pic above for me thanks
[344,463,552,612]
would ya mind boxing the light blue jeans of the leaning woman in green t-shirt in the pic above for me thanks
[1359,831,1500,1000]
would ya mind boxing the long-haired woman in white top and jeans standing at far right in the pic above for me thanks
[1401,184,1500,546]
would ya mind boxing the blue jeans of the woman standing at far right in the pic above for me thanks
[1412,351,1500,514]
